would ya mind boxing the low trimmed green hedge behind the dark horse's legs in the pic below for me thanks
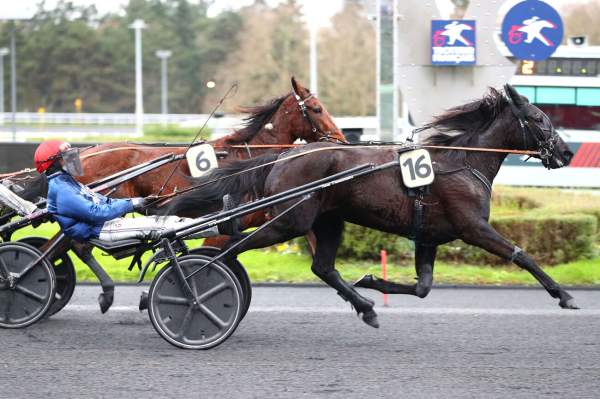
[338,214,598,265]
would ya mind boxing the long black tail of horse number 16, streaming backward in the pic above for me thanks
[153,154,279,217]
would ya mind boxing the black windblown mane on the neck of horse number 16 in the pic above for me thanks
[423,87,507,154]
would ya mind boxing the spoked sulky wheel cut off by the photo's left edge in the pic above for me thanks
[0,242,56,328]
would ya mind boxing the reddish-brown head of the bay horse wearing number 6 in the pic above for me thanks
[267,77,347,143]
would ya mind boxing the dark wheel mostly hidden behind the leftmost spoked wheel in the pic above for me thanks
[18,237,77,316]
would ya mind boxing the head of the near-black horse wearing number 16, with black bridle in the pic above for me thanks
[504,84,573,169]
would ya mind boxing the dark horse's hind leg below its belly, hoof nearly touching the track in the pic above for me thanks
[311,214,379,328]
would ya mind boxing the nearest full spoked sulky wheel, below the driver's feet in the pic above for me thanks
[148,255,243,349]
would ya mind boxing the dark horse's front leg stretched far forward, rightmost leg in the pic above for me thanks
[462,221,579,309]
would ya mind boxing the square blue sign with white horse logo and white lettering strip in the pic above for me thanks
[431,19,475,65]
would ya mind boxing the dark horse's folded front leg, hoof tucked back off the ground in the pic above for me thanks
[354,243,437,298]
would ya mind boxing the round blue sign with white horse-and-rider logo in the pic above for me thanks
[502,0,563,61]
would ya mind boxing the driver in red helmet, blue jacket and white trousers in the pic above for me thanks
[34,141,239,242]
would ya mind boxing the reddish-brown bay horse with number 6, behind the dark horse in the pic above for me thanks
[1,77,346,247]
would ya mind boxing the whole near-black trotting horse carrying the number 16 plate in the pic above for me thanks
[163,85,577,327]
